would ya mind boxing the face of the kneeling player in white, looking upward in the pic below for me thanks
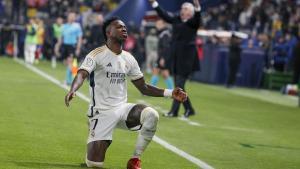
[109,20,128,42]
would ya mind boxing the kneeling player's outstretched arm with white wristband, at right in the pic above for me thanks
[132,77,187,102]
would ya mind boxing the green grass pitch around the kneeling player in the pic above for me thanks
[0,57,300,169]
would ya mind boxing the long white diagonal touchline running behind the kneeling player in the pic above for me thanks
[15,59,214,169]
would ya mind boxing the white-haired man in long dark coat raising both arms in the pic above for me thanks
[149,0,201,117]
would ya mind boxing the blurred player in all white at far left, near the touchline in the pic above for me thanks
[24,18,38,64]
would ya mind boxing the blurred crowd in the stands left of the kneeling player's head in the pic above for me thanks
[0,0,120,60]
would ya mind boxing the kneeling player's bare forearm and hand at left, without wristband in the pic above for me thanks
[65,70,89,106]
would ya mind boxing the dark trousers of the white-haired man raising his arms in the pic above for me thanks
[171,75,194,115]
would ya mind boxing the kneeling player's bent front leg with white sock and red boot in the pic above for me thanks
[126,104,159,169]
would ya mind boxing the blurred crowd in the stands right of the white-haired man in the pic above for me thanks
[203,0,300,71]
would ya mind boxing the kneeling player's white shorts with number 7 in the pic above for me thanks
[87,103,136,143]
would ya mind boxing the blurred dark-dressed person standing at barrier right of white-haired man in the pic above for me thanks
[227,34,242,87]
